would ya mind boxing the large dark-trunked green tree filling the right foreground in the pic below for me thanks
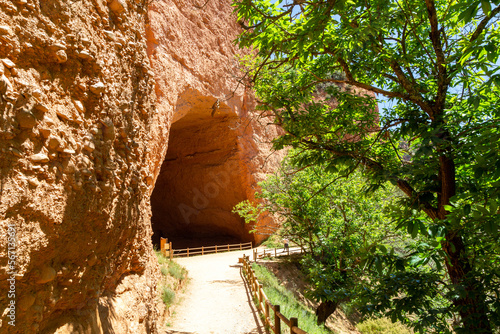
[234,0,500,333]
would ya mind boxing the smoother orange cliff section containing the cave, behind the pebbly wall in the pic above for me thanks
[147,0,280,247]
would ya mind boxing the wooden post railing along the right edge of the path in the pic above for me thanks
[241,256,307,334]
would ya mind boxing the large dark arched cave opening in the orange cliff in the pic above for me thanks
[147,98,253,249]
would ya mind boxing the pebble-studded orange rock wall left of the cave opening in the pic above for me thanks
[0,0,158,334]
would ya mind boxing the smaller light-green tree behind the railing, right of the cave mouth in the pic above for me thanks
[234,152,403,323]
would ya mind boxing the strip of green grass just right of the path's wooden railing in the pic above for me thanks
[252,263,332,334]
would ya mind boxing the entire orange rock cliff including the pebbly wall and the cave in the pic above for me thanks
[0,0,278,334]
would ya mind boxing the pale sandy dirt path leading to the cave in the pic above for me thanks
[166,250,265,334]
